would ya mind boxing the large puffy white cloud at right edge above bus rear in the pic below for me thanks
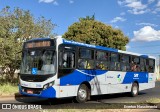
[131,26,160,42]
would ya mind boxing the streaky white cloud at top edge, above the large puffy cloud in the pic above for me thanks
[118,0,150,15]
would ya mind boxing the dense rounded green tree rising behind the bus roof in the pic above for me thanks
[62,15,129,50]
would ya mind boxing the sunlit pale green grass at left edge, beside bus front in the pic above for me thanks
[0,82,18,96]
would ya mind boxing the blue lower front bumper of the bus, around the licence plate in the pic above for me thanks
[19,85,56,98]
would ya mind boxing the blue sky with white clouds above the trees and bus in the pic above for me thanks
[0,0,160,62]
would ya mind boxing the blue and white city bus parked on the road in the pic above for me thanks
[19,38,156,103]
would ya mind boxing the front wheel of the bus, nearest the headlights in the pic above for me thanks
[76,84,89,103]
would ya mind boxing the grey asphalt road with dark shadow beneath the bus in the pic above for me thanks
[0,81,160,108]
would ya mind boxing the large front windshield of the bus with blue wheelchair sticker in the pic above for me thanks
[20,50,56,75]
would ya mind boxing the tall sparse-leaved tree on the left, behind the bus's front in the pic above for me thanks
[0,6,55,81]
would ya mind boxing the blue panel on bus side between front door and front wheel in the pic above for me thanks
[60,70,107,86]
